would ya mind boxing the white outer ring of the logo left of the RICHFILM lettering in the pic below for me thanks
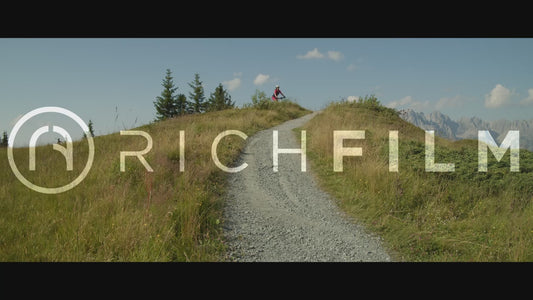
[7,106,94,194]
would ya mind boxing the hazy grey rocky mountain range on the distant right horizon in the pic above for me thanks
[400,109,533,151]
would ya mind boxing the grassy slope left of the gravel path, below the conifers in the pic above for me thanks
[0,102,309,261]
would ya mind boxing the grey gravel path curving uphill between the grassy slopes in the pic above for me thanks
[223,112,390,262]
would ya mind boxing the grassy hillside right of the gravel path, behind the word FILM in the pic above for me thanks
[302,97,533,261]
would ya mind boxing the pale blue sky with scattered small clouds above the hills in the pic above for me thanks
[0,38,533,139]
